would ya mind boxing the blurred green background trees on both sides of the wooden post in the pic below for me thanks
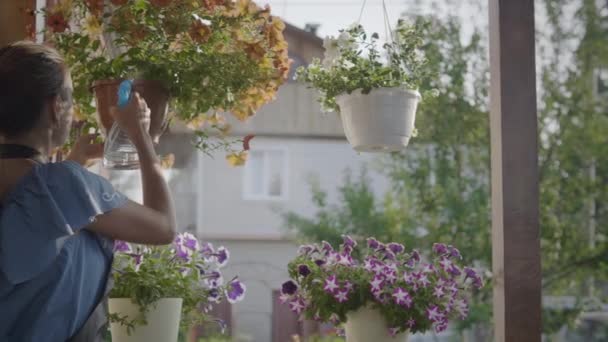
[284,0,608,332]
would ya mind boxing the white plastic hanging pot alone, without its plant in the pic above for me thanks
[336,88,420,152]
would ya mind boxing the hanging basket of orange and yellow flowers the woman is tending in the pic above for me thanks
[42,0,290,162]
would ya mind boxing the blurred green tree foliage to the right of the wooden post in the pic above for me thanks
[539,0,608,295]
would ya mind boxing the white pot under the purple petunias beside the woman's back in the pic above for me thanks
[109,298,182,342]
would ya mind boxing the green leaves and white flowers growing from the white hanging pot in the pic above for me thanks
[296,20,430,112]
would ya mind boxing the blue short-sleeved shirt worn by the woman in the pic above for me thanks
[0,161,127,342]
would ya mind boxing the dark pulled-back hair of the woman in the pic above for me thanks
[0,41,69,138]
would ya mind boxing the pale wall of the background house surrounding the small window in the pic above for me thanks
[196,137,388,240]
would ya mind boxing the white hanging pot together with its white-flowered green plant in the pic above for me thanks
[296,21,436,152]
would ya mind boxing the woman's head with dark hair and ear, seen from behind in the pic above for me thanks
[0,41,72,147]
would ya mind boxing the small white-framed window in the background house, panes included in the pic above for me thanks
[243,149,287,200]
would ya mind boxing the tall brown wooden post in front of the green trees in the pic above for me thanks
[489,0,541,342]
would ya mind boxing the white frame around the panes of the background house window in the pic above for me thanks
[243,145,289,201]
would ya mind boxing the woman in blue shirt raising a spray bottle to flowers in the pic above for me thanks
[0,42,175,342]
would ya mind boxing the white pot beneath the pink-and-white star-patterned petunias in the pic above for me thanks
[345,307,408,342]
